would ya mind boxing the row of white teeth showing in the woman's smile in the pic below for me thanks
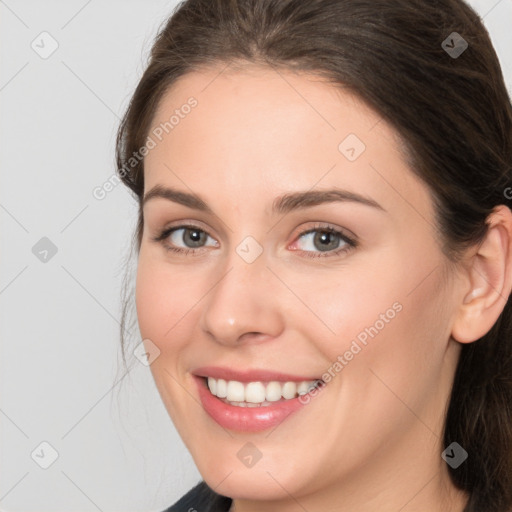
[208,377,320,407]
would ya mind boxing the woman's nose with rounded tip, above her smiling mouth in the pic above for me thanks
[200,251,284,345]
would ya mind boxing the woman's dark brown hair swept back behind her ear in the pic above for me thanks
[116,0,512,512]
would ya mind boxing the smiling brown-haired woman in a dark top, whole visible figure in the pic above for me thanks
[117,0,512,512]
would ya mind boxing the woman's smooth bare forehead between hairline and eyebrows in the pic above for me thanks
[145,65,429,225]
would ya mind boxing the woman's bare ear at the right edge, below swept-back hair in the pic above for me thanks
[451,205,512,343]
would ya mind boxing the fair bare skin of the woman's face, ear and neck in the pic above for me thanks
[136,65,512,512]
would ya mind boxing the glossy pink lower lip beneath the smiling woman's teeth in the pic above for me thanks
[194,376,322,432]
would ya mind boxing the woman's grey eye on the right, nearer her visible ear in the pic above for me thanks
[294,225,357,258]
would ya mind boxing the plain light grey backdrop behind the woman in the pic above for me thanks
[0,0,512,512]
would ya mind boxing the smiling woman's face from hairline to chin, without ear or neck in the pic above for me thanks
[136,67,459,500]
